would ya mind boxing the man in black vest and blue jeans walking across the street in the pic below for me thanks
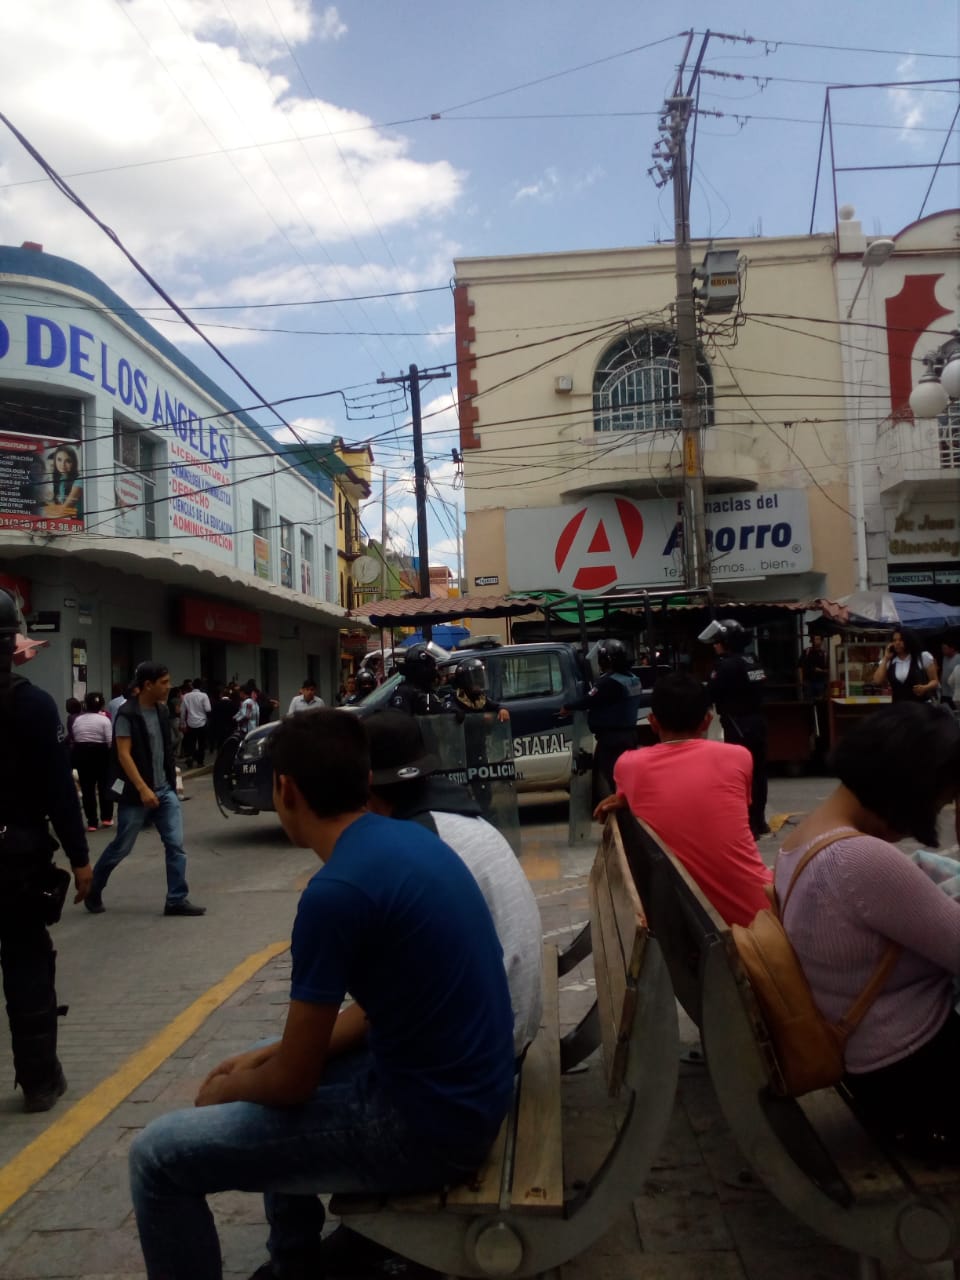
[83,662,206,915]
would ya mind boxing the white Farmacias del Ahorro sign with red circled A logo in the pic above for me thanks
[506,489,813,593]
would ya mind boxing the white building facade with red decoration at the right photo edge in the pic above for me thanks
[836,210,960,605]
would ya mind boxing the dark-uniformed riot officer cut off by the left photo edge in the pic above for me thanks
[0,590,92,1111]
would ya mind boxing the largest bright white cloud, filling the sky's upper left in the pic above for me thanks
[0,0,463,305]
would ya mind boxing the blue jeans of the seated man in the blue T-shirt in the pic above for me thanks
[129,1051,484,1280]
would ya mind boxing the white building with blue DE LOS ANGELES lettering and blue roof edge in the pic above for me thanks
[0,246,353,705]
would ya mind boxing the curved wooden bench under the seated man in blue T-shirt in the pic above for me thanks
[330,823,678,1277]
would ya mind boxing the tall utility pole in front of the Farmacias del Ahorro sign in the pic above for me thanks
[649,31,710,588]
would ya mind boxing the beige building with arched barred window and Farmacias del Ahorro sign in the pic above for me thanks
[454,236,852,629]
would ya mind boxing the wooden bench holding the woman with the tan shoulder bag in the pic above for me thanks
[620,814,960,1280]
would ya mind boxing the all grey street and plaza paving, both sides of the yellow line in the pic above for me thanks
[0,778,952,1280]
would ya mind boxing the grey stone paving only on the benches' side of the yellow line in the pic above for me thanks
[0,780,952,1280]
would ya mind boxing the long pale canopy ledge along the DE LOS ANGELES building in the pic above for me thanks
[0,530,365,630]
